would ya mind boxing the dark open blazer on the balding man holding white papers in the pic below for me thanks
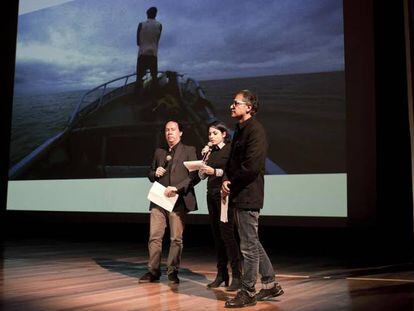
[148,142,200,211]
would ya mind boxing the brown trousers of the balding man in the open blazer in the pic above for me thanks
[148,206,185,275]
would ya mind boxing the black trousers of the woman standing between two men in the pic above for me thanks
[207,192,241,278]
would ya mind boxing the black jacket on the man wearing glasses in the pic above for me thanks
[223,118,268,210]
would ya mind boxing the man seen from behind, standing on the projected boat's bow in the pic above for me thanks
[137,7,162,90]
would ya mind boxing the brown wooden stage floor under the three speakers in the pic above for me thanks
[0,239,414,311]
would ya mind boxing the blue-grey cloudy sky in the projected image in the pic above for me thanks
[15,0,344,94]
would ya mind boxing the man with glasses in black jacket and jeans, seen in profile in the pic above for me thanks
[221,90,283,308]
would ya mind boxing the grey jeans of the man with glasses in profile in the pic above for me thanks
[235,209,275,295]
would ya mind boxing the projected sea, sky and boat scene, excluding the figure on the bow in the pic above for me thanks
[9,0,346,180]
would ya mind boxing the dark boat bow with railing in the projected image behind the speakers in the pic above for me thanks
[9,71,284,180]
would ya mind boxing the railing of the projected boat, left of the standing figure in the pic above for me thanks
[67,73,136,128]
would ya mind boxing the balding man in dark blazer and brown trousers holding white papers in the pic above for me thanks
[139,121,200,283]
